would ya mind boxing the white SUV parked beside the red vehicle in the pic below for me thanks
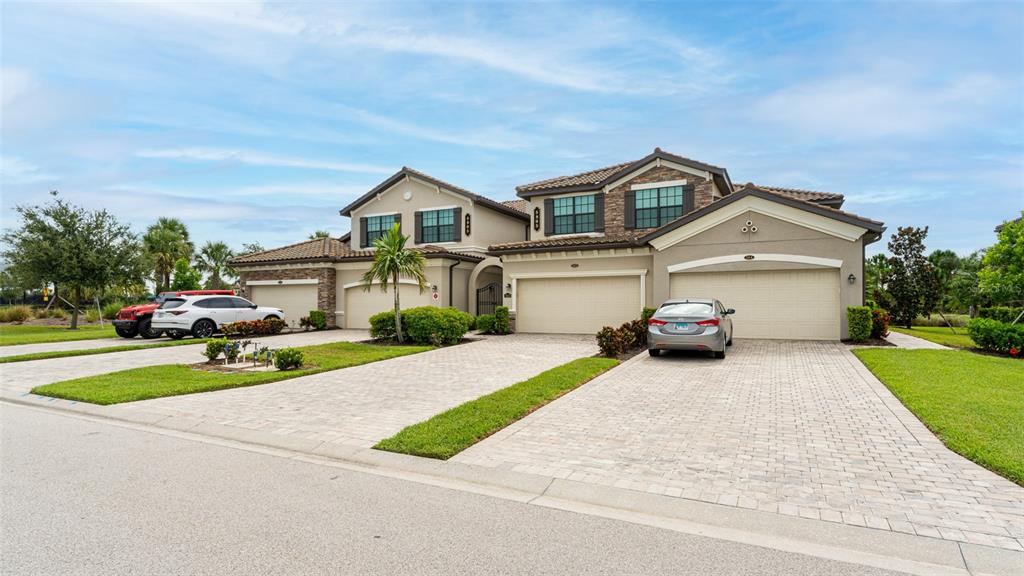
[153,295,285,338]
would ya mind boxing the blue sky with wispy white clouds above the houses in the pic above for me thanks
[0,2,1024,253]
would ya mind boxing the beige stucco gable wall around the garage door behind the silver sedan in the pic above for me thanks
[652,211,863,338]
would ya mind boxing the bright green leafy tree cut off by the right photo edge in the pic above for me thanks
[978,211,1024,305]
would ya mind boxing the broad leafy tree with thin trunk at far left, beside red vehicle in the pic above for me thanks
[3,192,142,329]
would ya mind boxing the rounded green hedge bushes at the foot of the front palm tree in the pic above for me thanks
[370,306,473,346]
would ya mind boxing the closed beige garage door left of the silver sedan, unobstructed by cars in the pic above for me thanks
[515,276,642,334]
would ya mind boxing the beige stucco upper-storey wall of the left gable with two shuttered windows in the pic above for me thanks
[351,178,526,253]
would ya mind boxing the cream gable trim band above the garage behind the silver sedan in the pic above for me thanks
[649,197,867,250]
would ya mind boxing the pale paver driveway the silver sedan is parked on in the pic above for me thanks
[454,340,1024,550]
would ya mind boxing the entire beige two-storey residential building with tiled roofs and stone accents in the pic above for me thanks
[233,149,885,339]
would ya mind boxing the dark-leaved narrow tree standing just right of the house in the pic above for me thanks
[884,227,938,328]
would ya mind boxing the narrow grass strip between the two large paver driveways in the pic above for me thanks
[374,358,618,460]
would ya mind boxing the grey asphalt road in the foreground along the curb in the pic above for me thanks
[0,403,909,576]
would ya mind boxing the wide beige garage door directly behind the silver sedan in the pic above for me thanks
[671,269,840,340]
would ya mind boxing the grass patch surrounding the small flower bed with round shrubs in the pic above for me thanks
[32,342,431,405]
